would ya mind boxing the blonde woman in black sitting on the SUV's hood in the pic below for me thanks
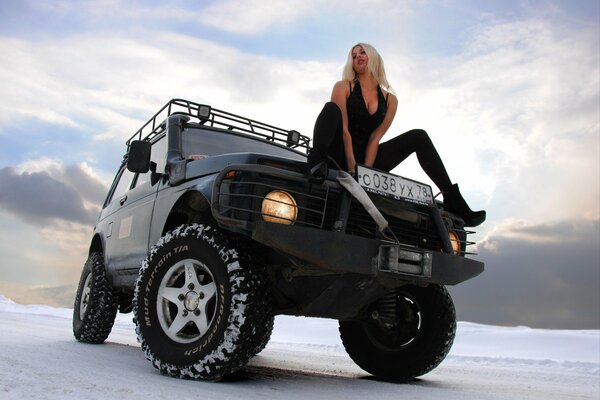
[308,43,486,226]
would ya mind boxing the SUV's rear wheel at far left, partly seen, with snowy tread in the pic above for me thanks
[73,253,119,344]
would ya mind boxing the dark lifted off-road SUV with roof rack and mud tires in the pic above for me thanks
[73,99,483,381]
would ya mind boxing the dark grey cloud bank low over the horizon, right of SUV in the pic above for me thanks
[451,219,600,328]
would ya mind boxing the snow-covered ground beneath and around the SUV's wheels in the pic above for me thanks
[0,295,600,400]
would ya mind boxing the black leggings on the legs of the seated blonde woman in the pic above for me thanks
[308,102,452,191]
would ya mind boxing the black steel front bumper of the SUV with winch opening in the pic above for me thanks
[252,222,484,285]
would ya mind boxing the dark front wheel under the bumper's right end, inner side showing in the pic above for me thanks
[340,285,456,382]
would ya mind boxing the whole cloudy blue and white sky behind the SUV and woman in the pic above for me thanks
[0,0,600,328]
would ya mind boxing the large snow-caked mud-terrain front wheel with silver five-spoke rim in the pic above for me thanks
[133,224,272,380]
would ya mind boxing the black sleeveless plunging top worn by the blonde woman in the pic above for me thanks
[346,80,387,163]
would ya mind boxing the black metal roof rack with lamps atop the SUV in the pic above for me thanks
[126,99,310,154]
